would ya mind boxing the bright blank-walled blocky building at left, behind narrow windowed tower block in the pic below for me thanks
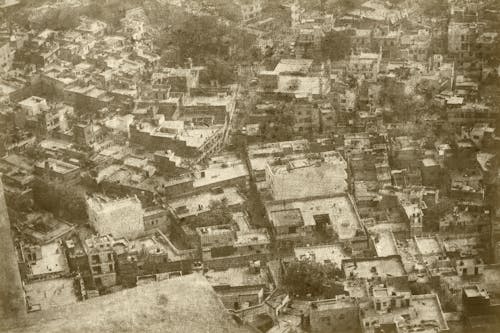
[87,195,145,239]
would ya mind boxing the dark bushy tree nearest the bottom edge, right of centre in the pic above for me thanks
[283,260,343,297]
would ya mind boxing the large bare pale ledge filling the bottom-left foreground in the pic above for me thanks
[0,274,253,333]
